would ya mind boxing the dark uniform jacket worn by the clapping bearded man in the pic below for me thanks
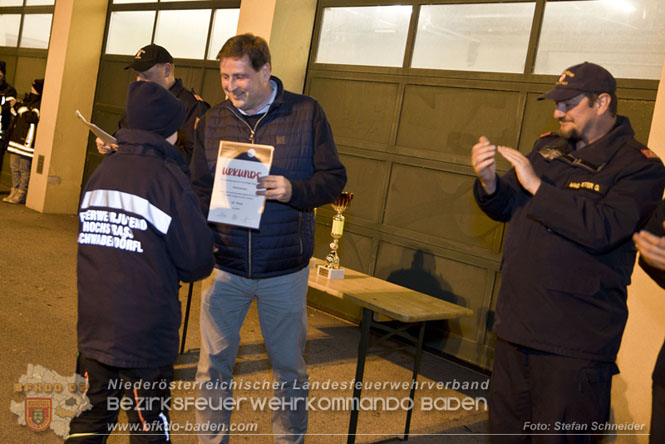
[474,116,665,362]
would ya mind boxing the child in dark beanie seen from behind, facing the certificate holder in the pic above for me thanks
[65,82,214,444]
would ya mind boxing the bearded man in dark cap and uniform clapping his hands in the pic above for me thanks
[471,62,665,442]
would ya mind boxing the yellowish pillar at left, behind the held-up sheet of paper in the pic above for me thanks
[26,0,108,214]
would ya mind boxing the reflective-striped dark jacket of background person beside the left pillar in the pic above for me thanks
[7,93,42,158]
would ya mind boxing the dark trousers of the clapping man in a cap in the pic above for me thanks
[489,339,618,444]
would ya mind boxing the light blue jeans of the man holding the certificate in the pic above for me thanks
[196,267,309,444]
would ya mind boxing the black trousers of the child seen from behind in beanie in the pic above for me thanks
[65,356,173,444]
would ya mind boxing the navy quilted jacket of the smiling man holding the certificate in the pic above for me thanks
[191,77,346,279]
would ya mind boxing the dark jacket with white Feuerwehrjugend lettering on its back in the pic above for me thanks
[77,129,214,368]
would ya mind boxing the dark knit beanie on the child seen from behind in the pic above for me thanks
[126,81,185,138]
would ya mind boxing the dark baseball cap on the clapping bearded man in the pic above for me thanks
[538,62,617,102]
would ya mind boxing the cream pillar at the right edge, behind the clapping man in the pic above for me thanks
[612,58,665,444]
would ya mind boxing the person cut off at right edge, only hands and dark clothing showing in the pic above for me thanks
[633,201,665,444]
